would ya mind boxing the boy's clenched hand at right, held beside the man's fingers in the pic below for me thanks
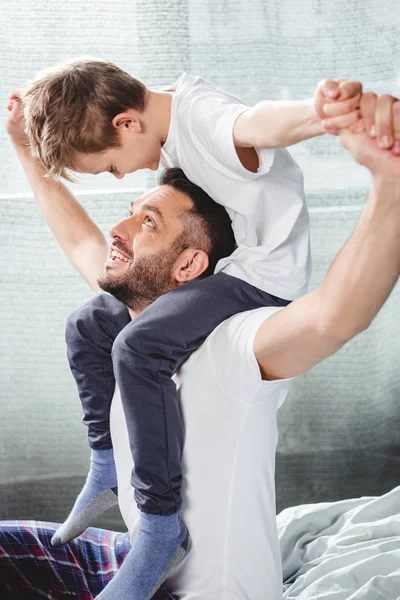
[314,79,362,135]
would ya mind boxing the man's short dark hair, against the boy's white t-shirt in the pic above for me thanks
[159,168,236,277]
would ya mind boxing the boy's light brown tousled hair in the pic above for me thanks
[20,57,148,181]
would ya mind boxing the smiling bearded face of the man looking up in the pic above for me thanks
[97,186,192,312]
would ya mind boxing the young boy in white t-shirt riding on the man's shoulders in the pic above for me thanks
[10,59,361,600]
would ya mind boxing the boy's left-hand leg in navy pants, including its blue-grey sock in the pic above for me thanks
[52,293,131,546]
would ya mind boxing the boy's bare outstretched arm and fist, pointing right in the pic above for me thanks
[233,79,362,148]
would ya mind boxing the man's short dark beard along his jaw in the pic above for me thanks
[97,237,184,312]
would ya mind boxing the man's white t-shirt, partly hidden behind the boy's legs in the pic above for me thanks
[111,307,289,600]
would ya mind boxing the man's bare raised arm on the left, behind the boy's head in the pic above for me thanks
[6,100,108,292]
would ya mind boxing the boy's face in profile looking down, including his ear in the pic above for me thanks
[76,111,161,179]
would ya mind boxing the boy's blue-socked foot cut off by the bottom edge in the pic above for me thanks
[97,513,189,600]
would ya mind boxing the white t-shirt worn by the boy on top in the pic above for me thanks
[160,73,311,300]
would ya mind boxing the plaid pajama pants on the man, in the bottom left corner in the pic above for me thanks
[0,521,174,600]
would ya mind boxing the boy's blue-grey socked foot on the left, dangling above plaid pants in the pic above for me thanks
[51,448,118,546]
